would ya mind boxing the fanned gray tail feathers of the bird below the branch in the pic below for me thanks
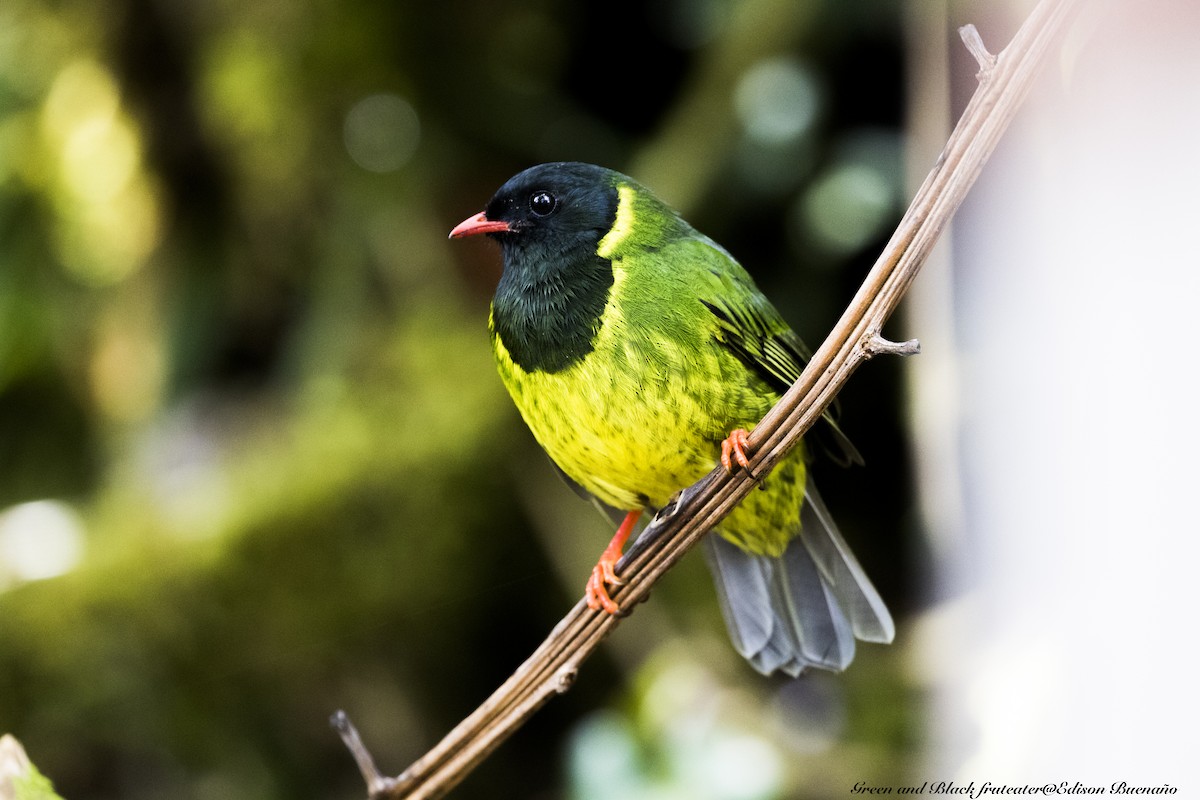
[703,479,895,676]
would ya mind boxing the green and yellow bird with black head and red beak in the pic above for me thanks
[450,162,895,676]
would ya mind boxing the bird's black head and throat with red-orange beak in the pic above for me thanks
[450,162,628,372]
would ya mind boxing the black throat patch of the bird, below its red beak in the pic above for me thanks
[492,241,613,373]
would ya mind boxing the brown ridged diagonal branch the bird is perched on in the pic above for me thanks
[334,0,1079,800]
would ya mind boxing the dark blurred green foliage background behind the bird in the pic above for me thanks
[0,0,919,800]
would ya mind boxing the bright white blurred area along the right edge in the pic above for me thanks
[907,0,1200,796]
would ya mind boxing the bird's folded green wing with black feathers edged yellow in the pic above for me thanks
[700,240,863,465]
